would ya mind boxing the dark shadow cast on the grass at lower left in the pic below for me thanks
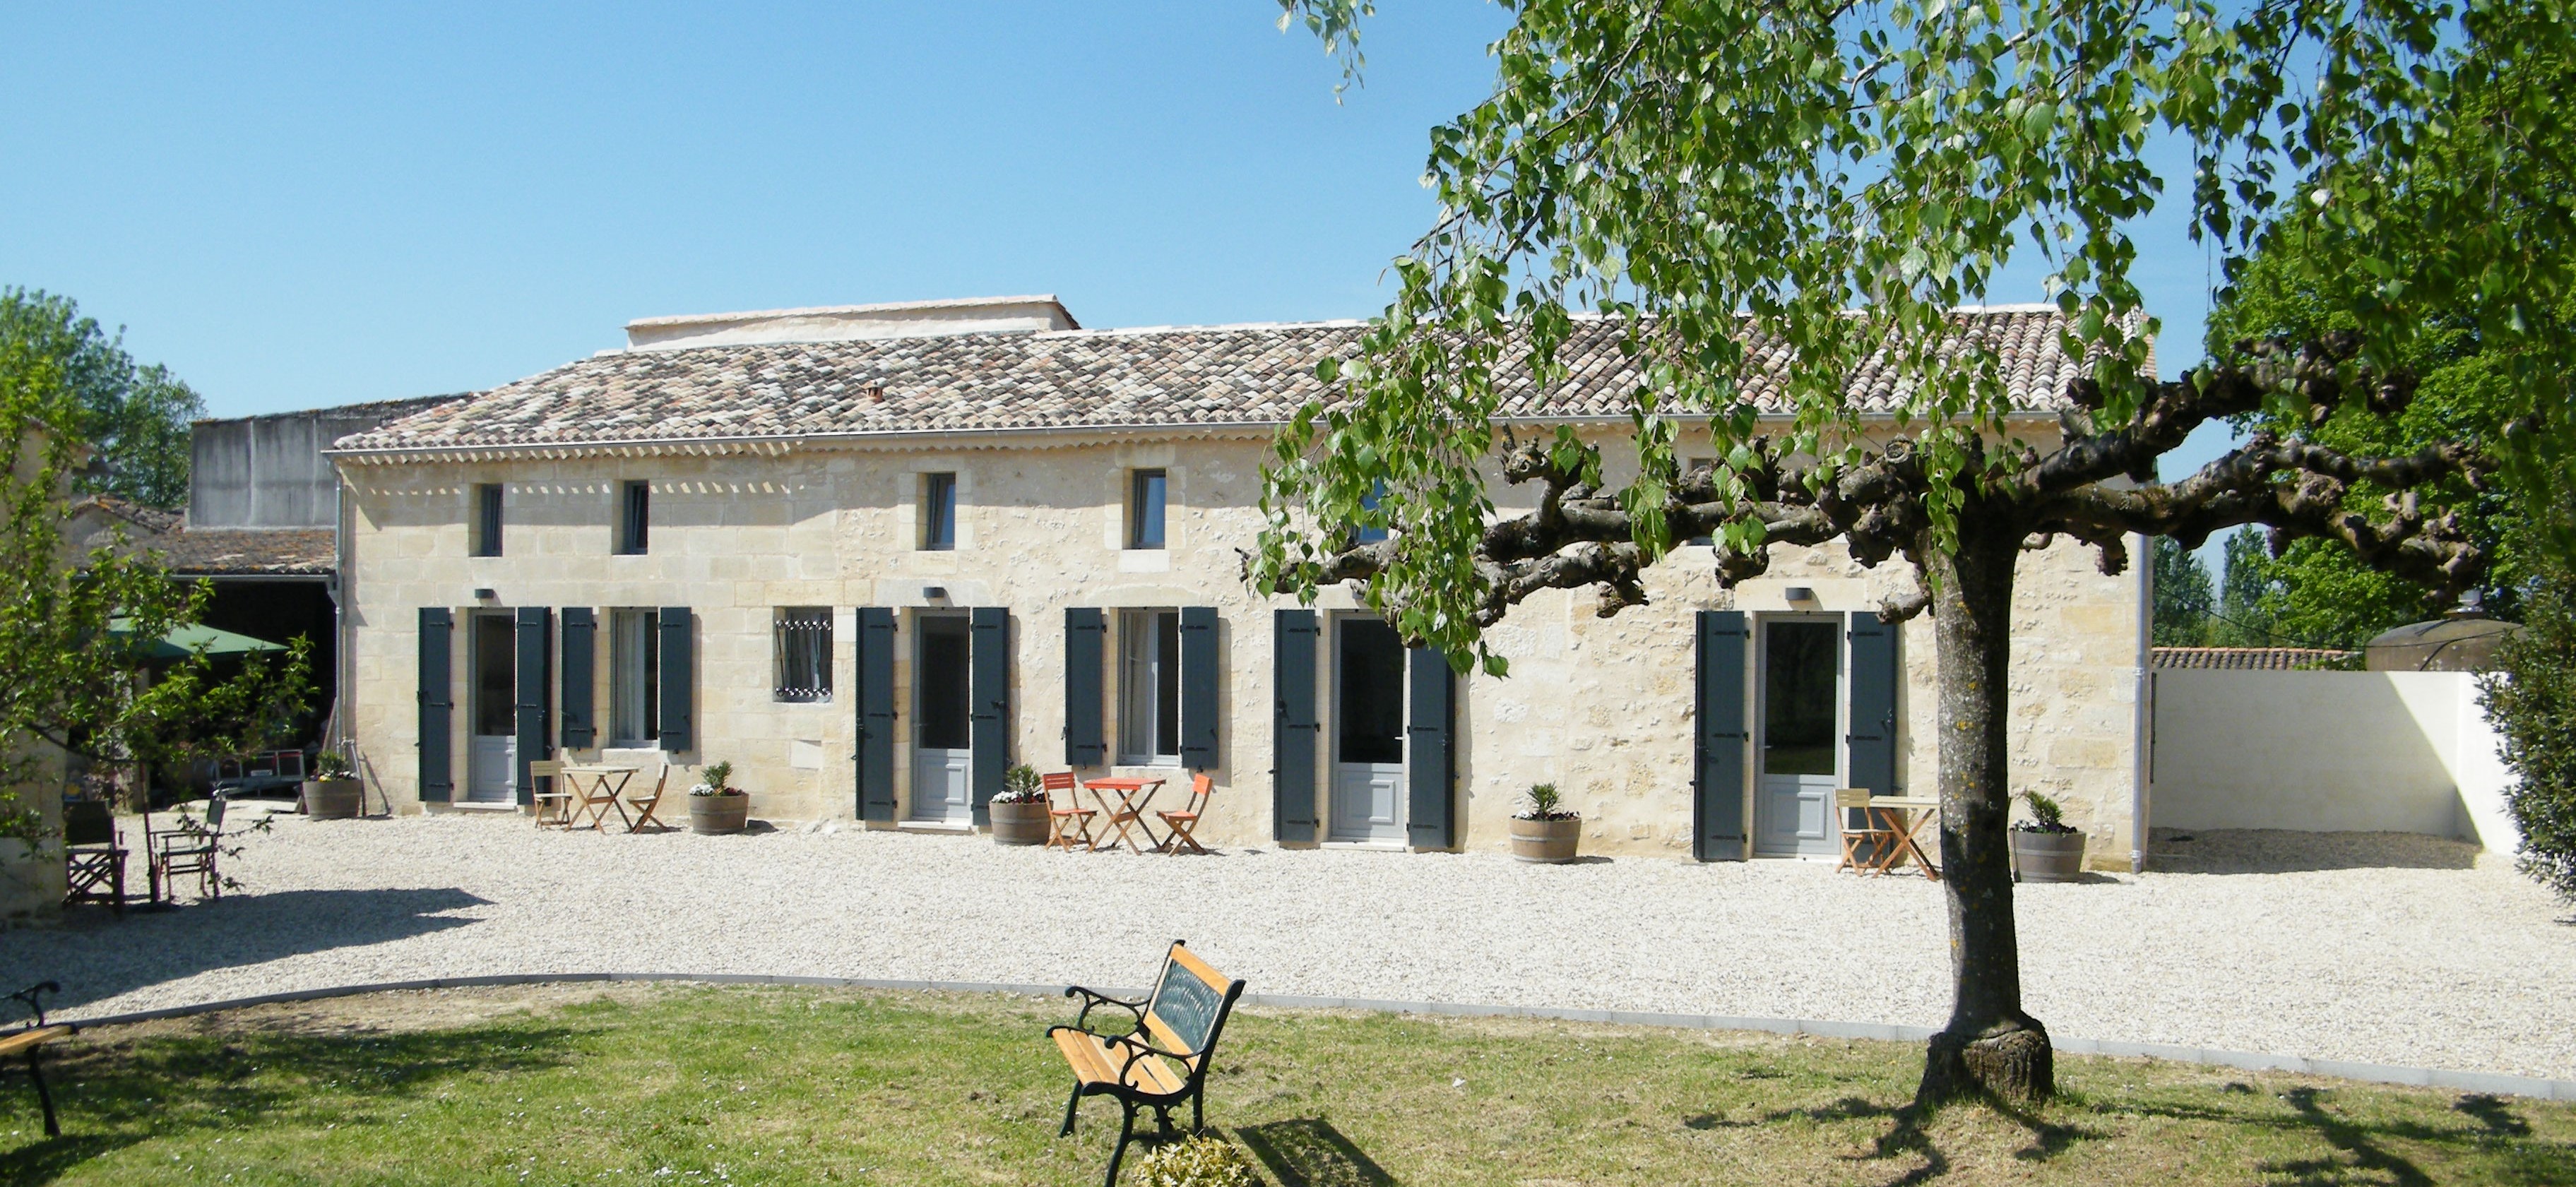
[0,1025,577,1187]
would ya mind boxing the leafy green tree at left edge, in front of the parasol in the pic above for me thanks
[0,340,309,845]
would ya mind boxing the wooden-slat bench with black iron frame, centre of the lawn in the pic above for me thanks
[1046,940,1245,1187]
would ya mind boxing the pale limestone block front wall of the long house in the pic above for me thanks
[343,424,2143,860]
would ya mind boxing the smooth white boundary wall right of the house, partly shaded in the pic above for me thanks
[2149,669,2519,852]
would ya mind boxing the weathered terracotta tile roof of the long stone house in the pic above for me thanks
[335,306,2076,451]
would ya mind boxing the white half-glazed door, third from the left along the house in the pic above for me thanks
[1326,615,1404,845]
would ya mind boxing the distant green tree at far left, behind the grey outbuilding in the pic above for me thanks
[0,288,206,510]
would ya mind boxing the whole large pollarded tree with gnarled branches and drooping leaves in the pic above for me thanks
[1252,0,2576,1099]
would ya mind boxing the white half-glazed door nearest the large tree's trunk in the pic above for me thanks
[1755,618,1842,857]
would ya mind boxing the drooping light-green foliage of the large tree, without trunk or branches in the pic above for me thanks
[1250,0,2576,674]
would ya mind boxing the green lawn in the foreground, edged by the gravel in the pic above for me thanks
[0,986,2576,1187]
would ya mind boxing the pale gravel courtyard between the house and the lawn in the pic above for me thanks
[0,813,2576,1079]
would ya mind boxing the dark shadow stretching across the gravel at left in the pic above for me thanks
[0,885,487,1020]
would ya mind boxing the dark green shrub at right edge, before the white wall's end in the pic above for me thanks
[2481,572,2576,904]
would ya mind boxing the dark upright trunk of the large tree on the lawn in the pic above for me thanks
[1916,517,2055,1102]
